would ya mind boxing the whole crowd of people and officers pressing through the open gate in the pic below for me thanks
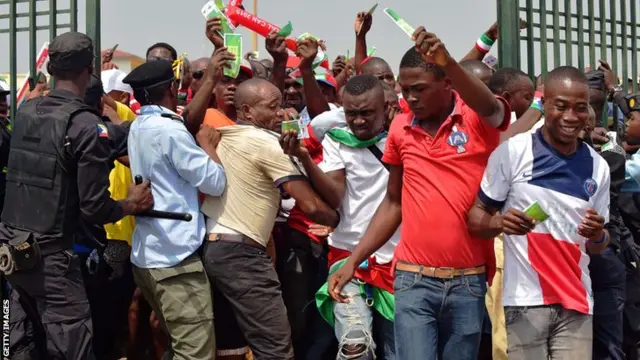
[0,4,640,360]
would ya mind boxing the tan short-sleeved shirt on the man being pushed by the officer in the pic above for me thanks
[202,125,304,246]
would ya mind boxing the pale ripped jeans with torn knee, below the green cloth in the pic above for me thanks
[333,279,396,360]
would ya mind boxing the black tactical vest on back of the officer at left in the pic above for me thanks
[2,97,95,238]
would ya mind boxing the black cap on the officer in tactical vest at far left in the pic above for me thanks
[49,31,94,71]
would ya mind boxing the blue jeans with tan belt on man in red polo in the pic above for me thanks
[393,270,487,360]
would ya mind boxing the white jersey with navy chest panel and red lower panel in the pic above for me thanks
[478,130,611,314]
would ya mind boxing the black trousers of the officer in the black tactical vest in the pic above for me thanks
[7,250,94,360]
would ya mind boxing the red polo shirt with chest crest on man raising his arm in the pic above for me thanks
[382,92,511,269]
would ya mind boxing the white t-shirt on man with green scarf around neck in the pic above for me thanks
[319,132,400,264]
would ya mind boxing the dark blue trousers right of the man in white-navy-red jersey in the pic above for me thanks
[589,248,626,360]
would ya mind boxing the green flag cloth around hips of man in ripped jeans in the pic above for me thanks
[316,259,396,326]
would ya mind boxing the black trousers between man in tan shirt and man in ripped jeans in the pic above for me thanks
[275,226,338,360]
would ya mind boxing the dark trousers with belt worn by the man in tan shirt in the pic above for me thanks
[202,241,294,360]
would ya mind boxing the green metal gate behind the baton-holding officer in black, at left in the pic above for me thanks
[0,0,100,119]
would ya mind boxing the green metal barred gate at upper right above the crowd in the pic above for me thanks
[497,0,640,92]
